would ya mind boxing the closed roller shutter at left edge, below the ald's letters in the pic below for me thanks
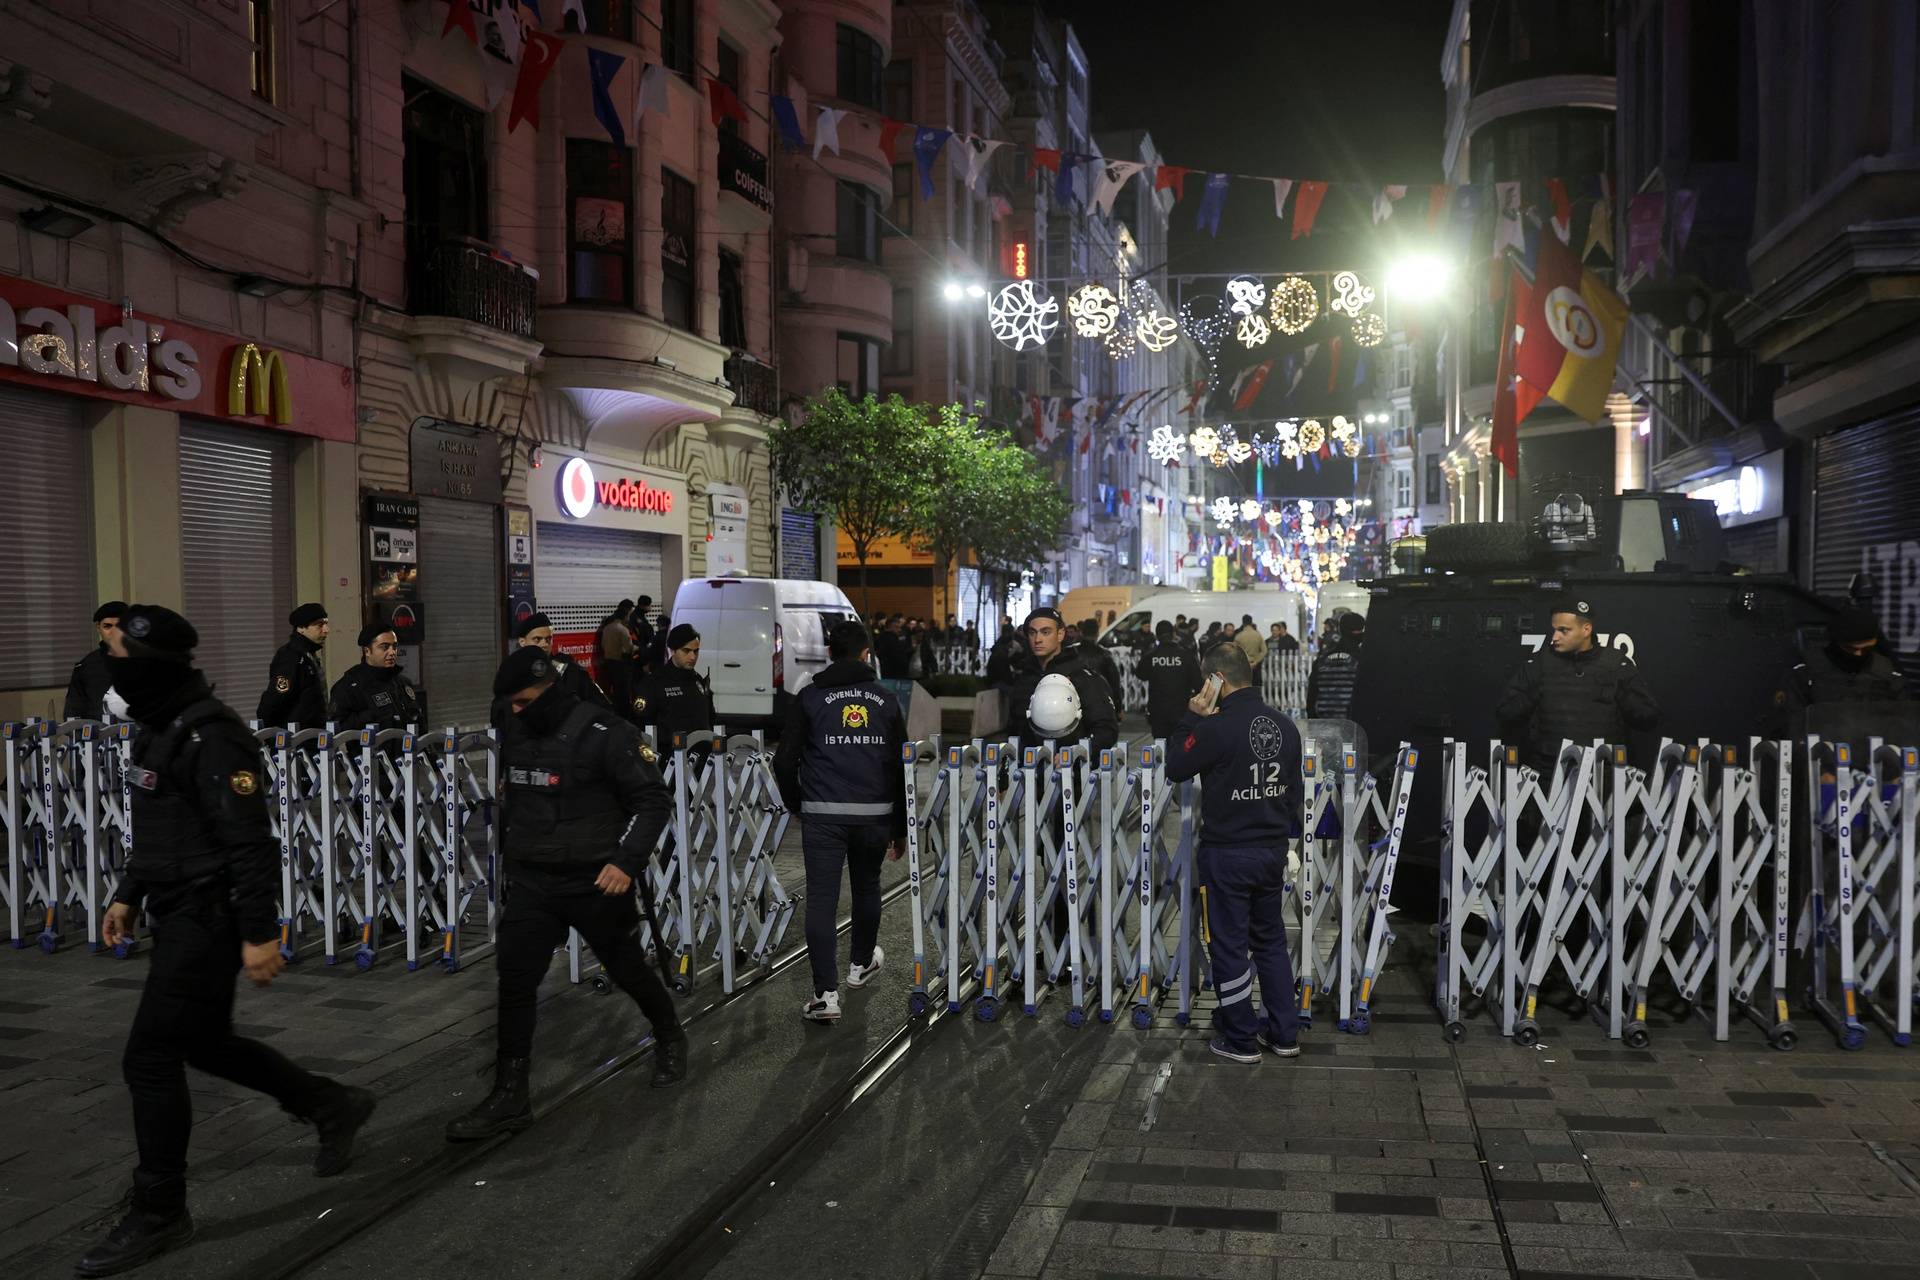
[0,388,100,694]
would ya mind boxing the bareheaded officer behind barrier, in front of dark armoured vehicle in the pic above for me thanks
[1494,601,1661,770]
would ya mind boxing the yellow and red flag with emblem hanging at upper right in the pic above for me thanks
[1513,236,1626,422]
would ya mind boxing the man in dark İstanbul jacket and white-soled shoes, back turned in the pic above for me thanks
[774,620,906,1023]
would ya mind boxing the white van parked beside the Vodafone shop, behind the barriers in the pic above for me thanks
[668,578,858,729]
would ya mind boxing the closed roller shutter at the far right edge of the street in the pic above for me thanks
[1812,407,1920,652]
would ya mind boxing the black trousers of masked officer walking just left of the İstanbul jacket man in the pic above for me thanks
[493,862,684,1057]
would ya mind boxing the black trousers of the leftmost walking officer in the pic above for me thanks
[121,890,336,1207]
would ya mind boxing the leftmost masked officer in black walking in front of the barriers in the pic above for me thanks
[77,604,374,1276]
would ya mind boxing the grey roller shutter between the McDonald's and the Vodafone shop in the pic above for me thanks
[420,497,503,729]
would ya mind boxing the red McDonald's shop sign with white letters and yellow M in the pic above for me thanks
[0,276,353,439]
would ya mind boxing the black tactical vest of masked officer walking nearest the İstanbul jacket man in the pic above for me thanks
[501,702,630,862]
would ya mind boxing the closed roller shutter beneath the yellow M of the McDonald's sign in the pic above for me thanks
[180,422,296,716]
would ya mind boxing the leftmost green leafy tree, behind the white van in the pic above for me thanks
[766,390,929,614]
